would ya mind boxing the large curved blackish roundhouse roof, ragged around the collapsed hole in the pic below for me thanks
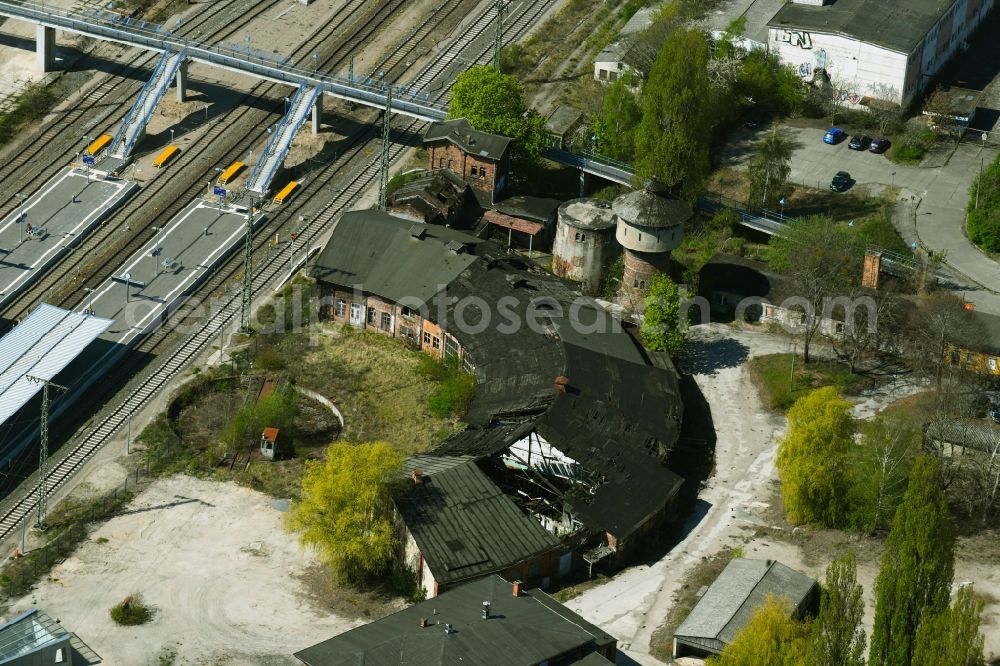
[314,216,683,538]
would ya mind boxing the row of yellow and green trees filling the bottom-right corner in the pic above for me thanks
[710,456,983,666]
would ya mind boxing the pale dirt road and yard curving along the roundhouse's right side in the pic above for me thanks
[566,324,1000,665]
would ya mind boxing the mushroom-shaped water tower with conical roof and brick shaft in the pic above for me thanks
[612,178,692,312]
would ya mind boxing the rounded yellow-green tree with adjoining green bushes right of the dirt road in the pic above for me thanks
[777,375,1000,534]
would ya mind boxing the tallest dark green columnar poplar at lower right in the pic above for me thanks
[868,456,955,666]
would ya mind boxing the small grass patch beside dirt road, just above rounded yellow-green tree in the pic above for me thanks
[748,354,869,412]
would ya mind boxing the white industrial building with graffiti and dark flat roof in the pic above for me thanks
[767,0,993,107]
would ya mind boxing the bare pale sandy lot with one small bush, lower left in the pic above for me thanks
[1,476,356,666]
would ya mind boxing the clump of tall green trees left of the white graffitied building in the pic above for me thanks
[593,9,805,199]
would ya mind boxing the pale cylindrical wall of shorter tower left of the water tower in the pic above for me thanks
[552,221,621,296]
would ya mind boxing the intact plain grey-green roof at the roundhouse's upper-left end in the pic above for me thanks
[312,210,483,307]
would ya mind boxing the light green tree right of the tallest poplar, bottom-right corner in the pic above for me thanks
[913,585,985,666]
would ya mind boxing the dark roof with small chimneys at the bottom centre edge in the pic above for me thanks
[295,576,616,666]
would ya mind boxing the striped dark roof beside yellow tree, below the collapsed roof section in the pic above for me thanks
[396,462,559,584]
